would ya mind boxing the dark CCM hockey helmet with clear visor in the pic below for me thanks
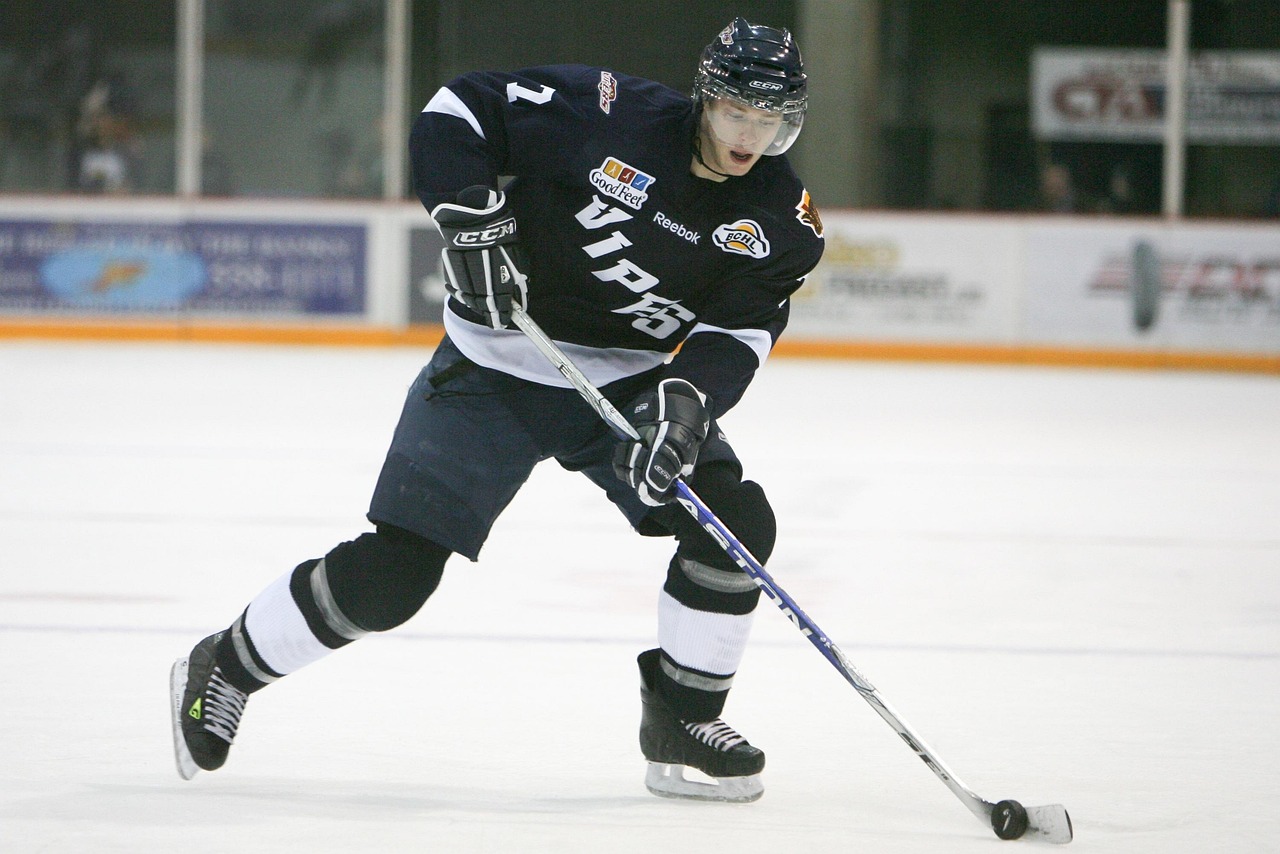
[694,18,809,155]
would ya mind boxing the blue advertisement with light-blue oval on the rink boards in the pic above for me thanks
[0,220,367,315]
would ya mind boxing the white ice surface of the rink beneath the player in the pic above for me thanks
[0,341,1280,854]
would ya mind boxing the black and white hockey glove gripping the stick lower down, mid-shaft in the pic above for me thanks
[613,379,710,507]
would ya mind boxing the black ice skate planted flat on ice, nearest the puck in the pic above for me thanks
[639,649,764,803]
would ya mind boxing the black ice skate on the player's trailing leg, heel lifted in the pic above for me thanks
[169,632,248,780]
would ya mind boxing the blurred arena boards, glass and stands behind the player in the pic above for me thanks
[0,0,1280,371]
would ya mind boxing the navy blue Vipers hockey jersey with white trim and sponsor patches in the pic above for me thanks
[410,65,823,415]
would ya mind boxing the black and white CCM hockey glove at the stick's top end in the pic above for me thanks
[431,186,529,329]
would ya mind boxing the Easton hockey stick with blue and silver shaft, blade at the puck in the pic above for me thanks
[511,306,1073,844]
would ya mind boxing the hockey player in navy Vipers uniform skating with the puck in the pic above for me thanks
[172,18,823,802]
